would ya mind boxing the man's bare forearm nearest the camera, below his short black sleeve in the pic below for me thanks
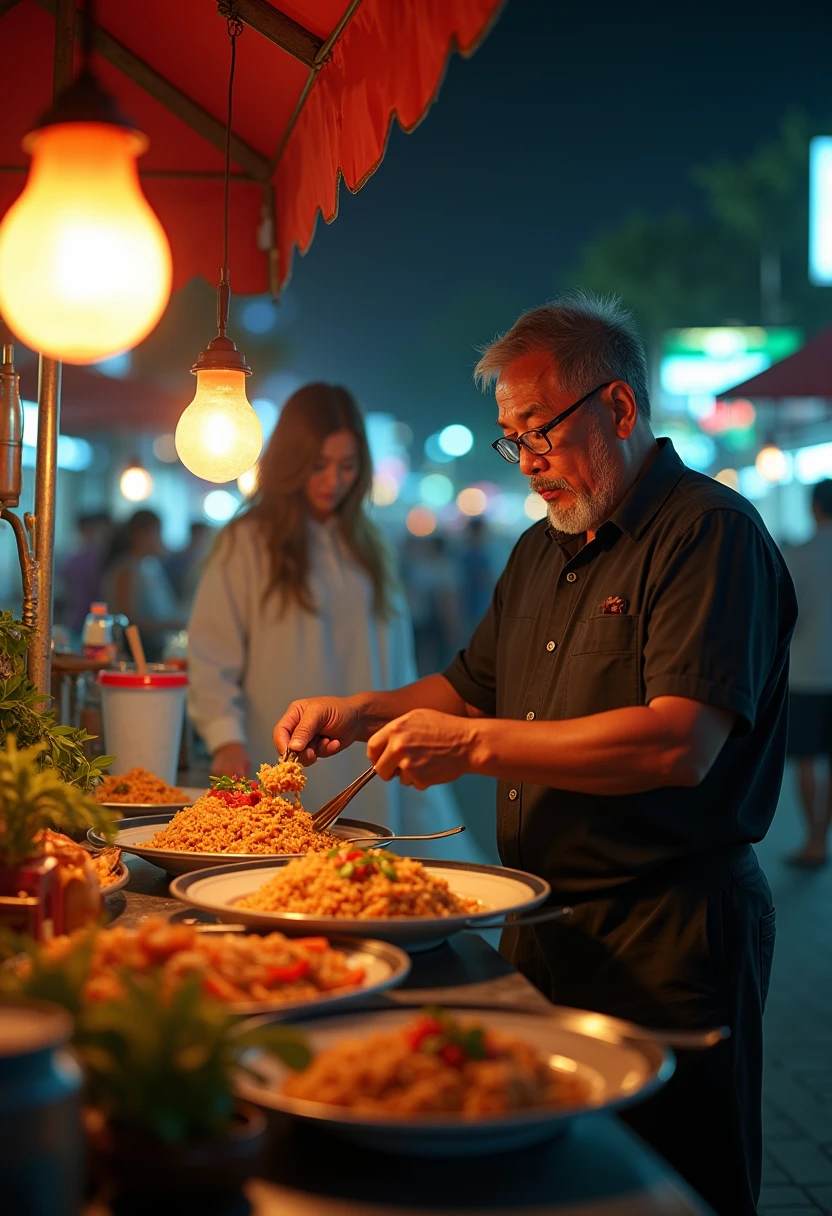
[471,705,704,794]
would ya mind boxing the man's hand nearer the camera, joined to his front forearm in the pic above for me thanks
[367,709,478,789]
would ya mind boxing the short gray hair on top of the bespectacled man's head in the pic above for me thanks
[474,291,650,420]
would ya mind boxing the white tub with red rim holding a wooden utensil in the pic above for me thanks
[99,670,187,786]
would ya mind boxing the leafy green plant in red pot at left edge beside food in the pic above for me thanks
[0,734,116,939]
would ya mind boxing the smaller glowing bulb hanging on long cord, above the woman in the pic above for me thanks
[174,17,256,482]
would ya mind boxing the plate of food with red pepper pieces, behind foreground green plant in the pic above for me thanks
[0,917,410,1017]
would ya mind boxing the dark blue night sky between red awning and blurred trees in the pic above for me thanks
[272,0,832,437]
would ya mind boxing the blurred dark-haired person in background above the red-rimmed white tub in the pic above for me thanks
[103,508,185,663]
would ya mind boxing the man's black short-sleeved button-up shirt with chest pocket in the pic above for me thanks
[445,439,797,895]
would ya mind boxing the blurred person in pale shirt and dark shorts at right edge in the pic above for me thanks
[785,480,832,868]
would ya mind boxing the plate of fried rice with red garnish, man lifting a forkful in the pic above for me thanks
[89,761,393,874]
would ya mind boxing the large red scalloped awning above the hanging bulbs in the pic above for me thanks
[0,0,501,294]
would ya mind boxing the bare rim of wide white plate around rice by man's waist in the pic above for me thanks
[170,856,550,951]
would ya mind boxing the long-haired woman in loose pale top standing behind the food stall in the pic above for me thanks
[189,383,467,846]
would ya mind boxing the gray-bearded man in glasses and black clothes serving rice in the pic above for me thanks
[275,294,797,1216]
